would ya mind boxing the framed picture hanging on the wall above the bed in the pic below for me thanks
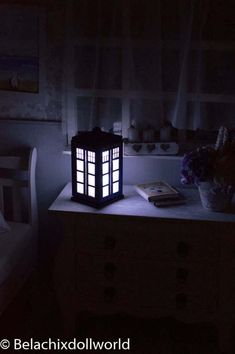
[0,2,39,93]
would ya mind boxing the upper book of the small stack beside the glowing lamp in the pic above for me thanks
[135,181,179,202]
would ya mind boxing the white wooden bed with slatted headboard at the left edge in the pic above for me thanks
[0,148,38,314]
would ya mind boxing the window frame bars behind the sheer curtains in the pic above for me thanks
[64,0,235,146]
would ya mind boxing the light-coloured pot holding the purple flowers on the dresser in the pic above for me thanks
[198,182,233,211]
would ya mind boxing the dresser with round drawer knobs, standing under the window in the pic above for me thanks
[50,184,235,354]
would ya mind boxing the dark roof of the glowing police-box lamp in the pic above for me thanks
[72,127,122,149]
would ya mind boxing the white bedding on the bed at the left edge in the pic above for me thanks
[0,222,33,285]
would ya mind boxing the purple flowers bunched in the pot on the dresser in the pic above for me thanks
[181,127,235,190]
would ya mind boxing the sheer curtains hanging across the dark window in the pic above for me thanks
[68,0,235,136]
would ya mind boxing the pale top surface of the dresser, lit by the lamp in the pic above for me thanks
[49,183,235,222]
